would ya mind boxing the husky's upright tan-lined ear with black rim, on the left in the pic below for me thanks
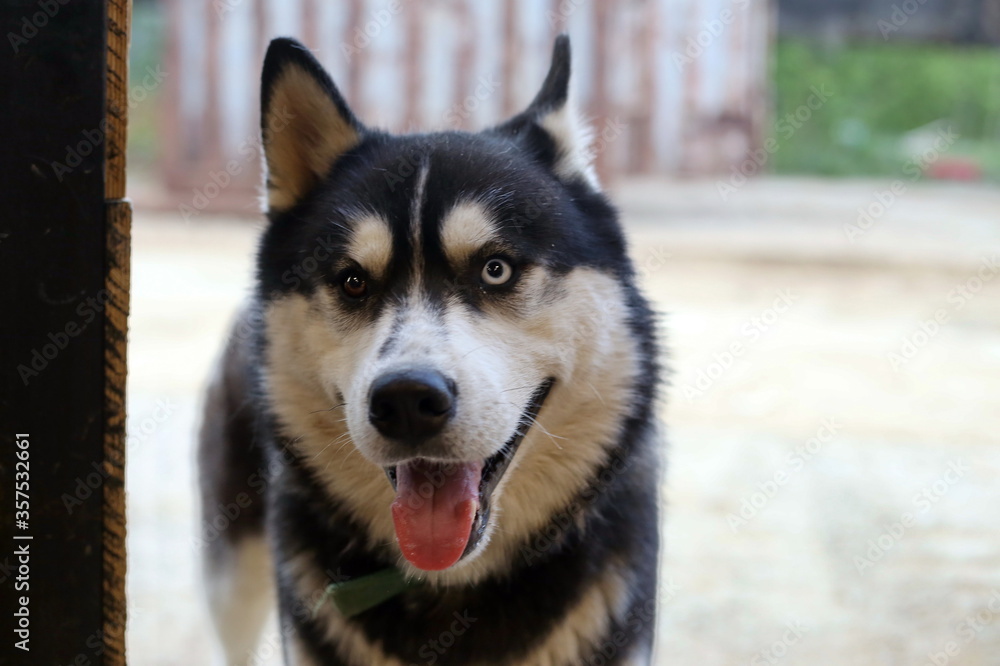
[260,38,364,210]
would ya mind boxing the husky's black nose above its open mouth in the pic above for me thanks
[368,370,455,441]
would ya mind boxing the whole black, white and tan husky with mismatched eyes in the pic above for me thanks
[199,36,660,666]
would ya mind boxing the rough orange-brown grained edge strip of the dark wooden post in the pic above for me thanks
[103,0,132,666]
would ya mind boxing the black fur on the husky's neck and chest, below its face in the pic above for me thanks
[262,420,659,666]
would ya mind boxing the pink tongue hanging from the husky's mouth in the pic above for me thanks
[392,460,483,571]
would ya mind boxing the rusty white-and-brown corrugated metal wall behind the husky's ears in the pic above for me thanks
[164,0,774,210]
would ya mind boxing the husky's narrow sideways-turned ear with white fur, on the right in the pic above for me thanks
[497,34,598,189]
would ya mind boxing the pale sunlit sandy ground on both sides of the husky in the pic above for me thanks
[128,180,1000,666]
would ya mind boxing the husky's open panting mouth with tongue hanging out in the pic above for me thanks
[385,378,555,571]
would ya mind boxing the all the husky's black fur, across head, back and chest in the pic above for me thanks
[201,36,659,666]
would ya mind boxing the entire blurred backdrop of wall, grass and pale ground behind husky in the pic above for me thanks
[128,0,1000,666]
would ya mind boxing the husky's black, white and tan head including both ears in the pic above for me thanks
[258,37,639,571]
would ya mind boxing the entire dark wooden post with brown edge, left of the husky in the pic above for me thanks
[0,0,130,666]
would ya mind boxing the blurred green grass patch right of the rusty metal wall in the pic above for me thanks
[773,40,1000,179]
